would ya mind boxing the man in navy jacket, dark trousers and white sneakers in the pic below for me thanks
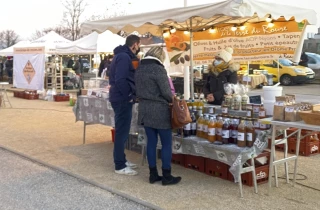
[109,35,140,175]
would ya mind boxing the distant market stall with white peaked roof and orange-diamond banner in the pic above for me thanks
[13,31,70,92]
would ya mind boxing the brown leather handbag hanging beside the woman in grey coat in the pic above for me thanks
[171,97,192,128]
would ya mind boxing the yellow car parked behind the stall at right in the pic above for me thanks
[241,59,315,85]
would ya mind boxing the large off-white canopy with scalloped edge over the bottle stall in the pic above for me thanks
[81,0,317,35]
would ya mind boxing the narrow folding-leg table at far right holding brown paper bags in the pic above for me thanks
[260,118,320,193]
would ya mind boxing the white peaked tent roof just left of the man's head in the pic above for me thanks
[56,30,125,54]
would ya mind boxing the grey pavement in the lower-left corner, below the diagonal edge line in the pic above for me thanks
[0,149,149,210]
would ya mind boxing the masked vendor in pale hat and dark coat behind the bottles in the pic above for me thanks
[203,47,240,105]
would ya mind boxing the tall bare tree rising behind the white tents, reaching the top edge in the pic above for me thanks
[62,0,88,41]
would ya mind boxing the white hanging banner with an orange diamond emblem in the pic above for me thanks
[13,47,45,90]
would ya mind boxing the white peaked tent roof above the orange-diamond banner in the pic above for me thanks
[19,31,71,54]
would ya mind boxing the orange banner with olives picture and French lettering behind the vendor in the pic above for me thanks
[164,21,304,66]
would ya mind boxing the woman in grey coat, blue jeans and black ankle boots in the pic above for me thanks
[135,46,181,185]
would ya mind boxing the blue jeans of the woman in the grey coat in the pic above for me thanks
[144,127,172,169]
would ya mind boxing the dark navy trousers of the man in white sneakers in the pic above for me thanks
[111,101,133,170]
